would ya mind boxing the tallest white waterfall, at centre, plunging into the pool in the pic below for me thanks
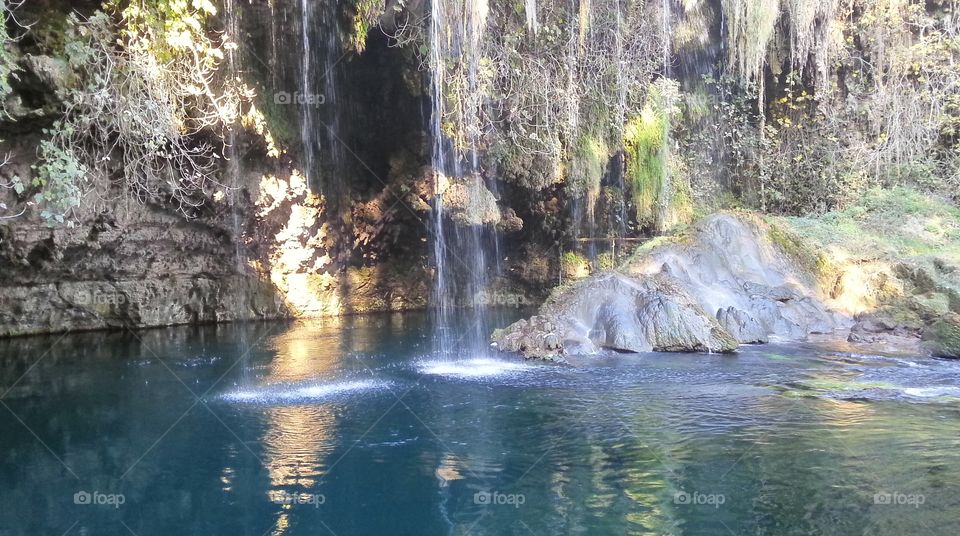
[429,0,498,356]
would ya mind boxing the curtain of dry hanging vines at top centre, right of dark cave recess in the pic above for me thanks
[420,0,662,194]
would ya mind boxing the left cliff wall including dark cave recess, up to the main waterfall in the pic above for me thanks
[0,0,430,336]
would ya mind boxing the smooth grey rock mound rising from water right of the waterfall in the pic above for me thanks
[493,214,849,357]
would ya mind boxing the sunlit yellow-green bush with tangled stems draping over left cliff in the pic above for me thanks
[28,0,247,222]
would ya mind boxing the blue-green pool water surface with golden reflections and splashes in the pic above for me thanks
[0,315,960,536]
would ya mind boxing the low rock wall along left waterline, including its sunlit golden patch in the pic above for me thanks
[0,133,429,336]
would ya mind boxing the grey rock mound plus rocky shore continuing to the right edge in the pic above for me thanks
[491,213,960,361]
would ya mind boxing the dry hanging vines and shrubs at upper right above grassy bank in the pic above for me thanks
[680,0,960,214]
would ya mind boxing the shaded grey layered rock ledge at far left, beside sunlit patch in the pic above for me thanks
[0,207,287,335]
